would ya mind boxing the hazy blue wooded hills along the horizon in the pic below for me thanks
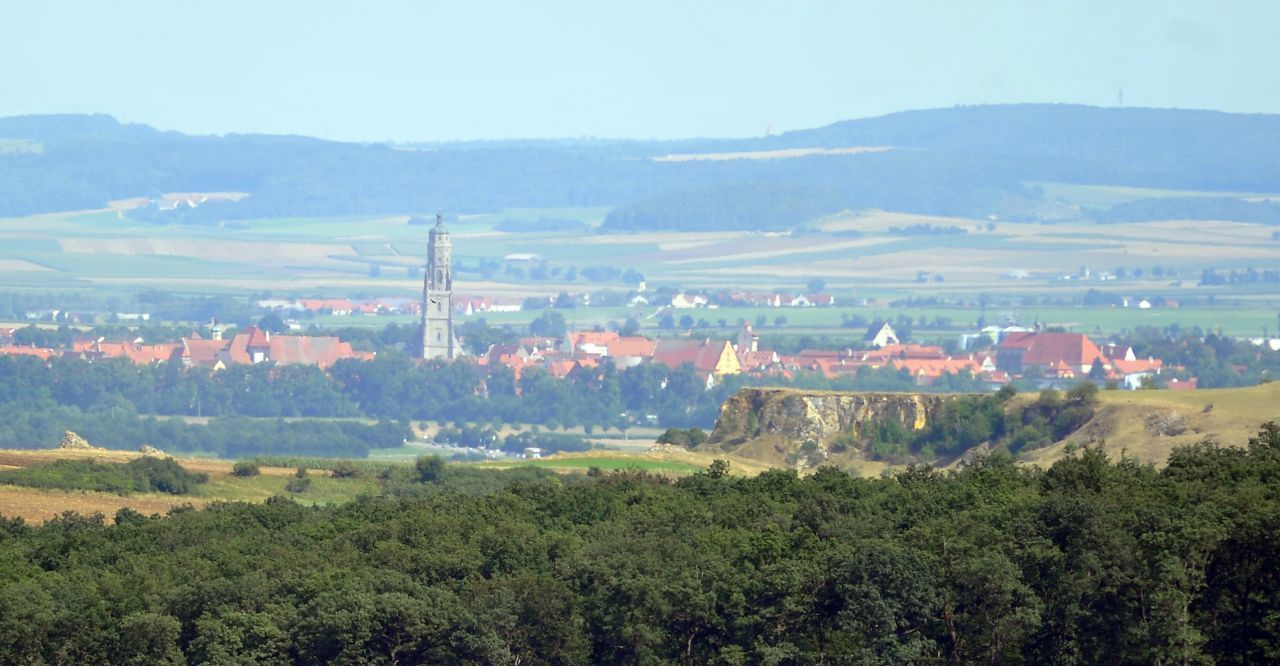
[0,105,1280,231]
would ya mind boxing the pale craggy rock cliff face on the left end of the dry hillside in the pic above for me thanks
[708,388,952,448]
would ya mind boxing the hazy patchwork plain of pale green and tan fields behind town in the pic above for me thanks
[0,183,1280,336]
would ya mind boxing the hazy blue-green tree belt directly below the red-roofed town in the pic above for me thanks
[0,351,980,457]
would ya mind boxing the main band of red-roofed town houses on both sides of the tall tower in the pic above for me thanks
[0,321,1177,388]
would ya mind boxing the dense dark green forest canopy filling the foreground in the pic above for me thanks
[0,424,1280,665]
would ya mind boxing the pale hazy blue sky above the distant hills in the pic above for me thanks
[0,0,1280,140]
